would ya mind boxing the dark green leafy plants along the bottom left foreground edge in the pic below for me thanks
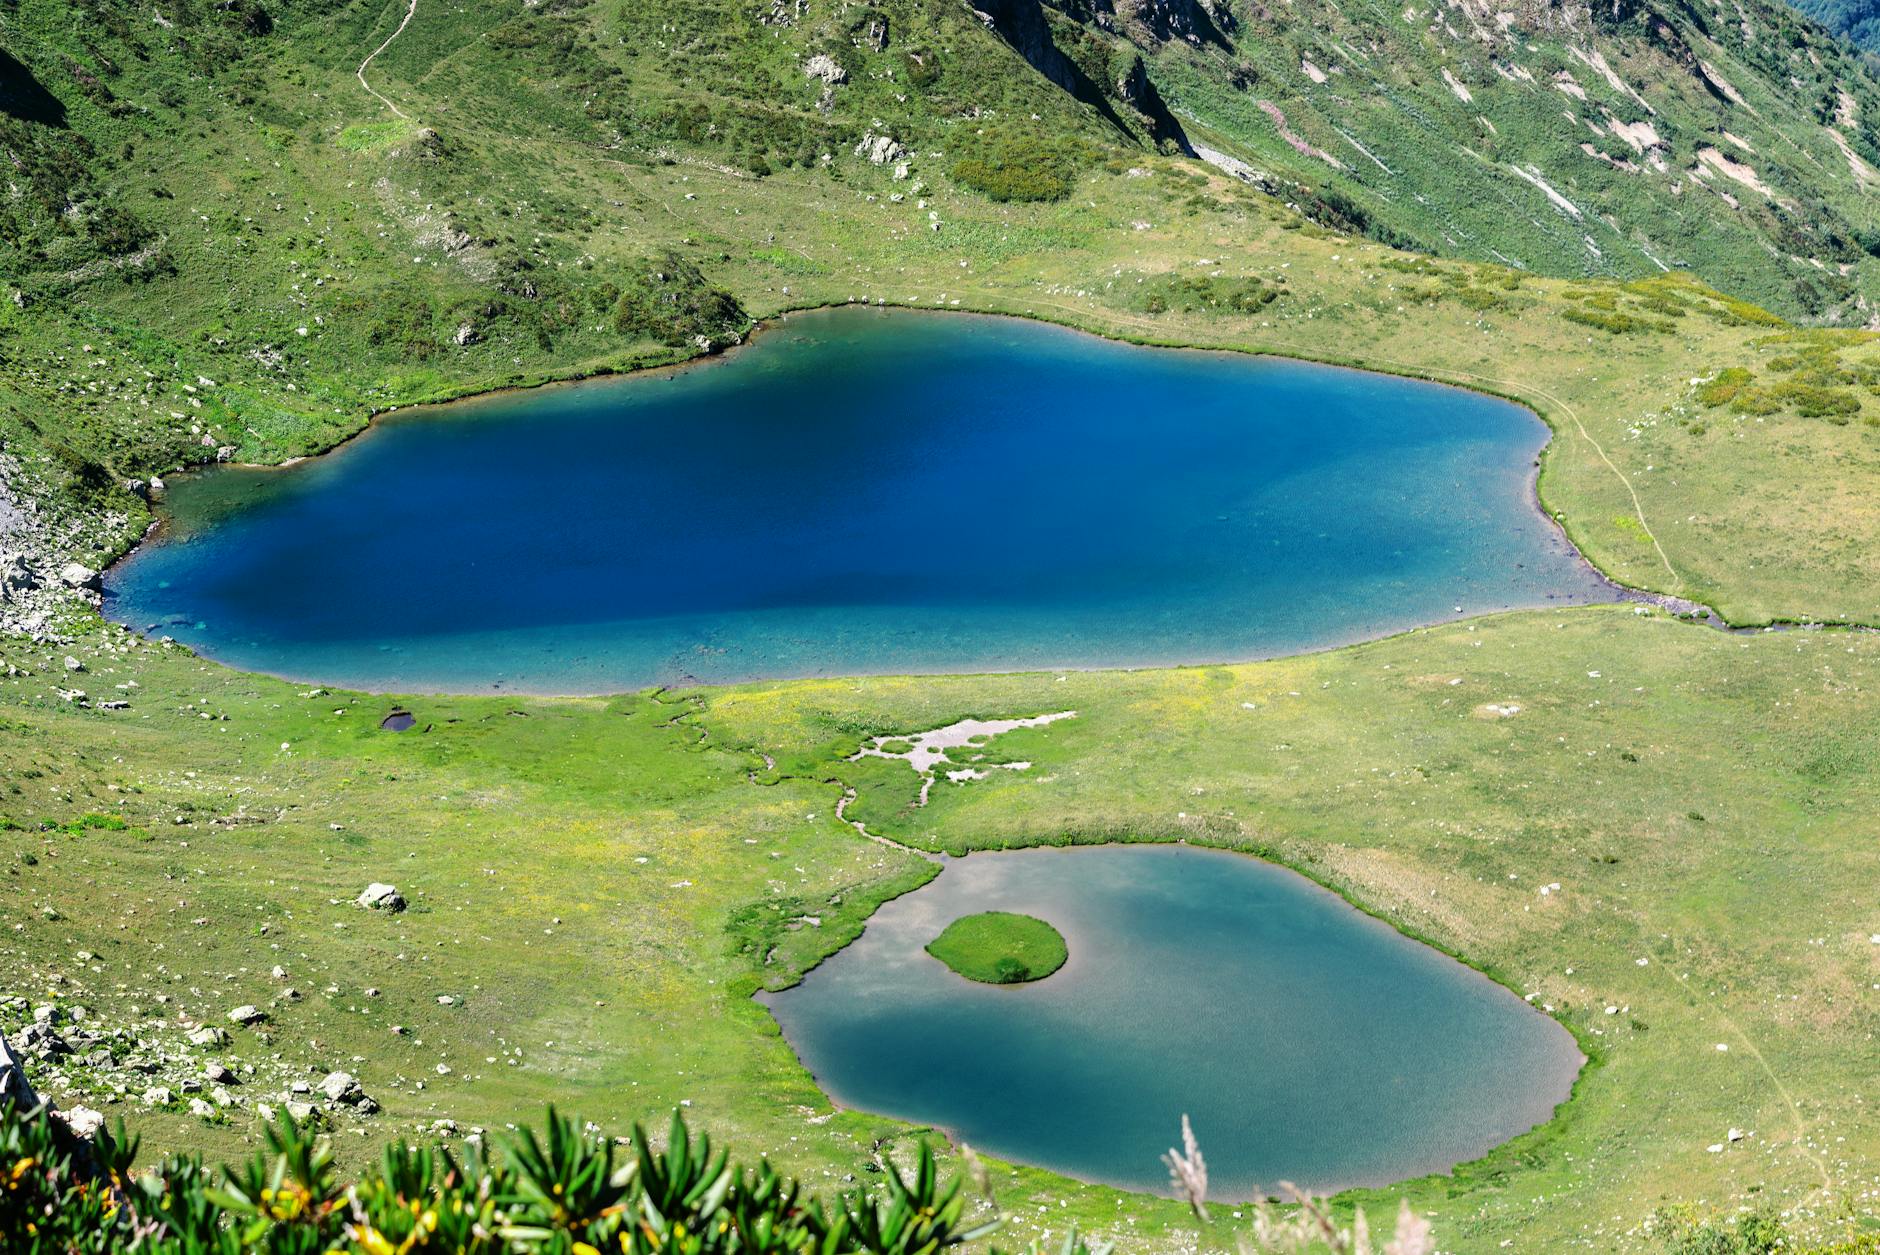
[0,1103,1000,1255]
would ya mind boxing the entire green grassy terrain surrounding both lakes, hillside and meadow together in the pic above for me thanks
[0,0,1880,1251]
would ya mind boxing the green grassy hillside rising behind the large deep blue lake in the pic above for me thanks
[11,0,1880,622]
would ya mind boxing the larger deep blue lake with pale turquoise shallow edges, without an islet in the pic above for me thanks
[107,310,1607,691]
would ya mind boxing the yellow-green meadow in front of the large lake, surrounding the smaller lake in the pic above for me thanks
[0,607,1880,1251]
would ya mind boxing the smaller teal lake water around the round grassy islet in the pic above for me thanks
[763,845,1583,1201]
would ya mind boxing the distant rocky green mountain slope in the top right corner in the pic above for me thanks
[1006,0,1880,323]
